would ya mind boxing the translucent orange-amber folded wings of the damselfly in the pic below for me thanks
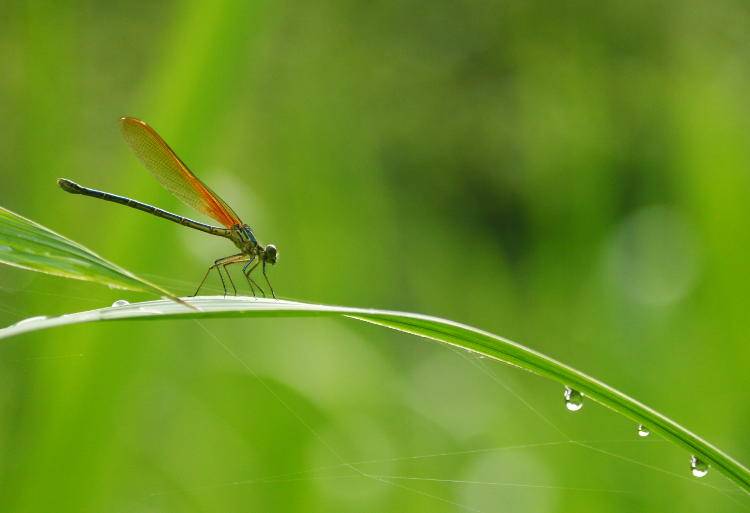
[120,118,242,228]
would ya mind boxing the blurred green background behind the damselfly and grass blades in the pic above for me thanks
[0,0,750,513]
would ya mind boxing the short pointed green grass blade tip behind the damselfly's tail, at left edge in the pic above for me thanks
[0,207,181,299]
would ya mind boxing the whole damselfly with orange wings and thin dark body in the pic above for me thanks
[57,118,279,299]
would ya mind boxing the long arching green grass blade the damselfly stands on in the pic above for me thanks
[0,296,750,493]
